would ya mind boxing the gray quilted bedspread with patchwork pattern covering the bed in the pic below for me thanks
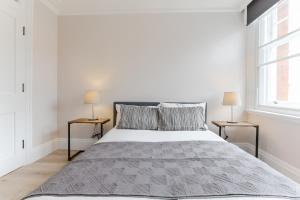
[28,141,300,199]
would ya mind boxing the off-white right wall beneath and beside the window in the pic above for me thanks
[244,23,300,182]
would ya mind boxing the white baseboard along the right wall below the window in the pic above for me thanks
[235,143,300,183]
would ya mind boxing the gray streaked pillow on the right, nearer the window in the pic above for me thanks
[158,106,206,131]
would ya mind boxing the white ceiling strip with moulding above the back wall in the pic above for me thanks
[41,0,251,15]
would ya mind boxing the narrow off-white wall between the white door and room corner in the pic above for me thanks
[31,0,58,147]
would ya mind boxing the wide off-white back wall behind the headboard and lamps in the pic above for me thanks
[58,13,245,138]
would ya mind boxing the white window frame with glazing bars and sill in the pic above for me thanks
[252,0,300,119]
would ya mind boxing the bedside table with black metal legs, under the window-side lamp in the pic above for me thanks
[211,121,259,158]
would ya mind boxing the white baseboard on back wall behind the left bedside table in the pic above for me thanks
[54,138,97,150]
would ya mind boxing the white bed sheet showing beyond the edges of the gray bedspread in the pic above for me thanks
[30,128,280,200]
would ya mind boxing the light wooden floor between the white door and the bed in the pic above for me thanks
[0,150,67,200]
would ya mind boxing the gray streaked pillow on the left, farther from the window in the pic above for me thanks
[117,105,158,130]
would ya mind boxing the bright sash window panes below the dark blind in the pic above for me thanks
[257,0,300,109]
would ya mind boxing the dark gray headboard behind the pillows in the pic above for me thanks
[113,101,207,126]
